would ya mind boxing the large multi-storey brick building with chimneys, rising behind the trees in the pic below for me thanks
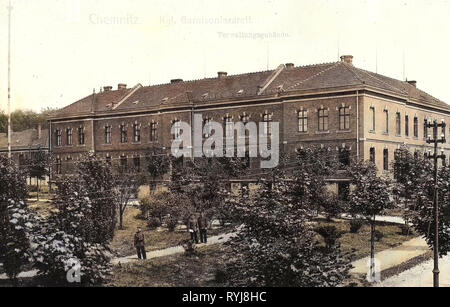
[49,56,450,185]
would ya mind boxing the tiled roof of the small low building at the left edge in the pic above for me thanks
[0,129,48,151]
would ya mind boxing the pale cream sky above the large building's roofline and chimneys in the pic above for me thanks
[0,0,450,111]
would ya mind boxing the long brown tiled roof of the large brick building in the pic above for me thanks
[49,61,450,118]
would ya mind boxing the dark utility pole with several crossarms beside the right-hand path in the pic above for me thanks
[427,120,446,288]
